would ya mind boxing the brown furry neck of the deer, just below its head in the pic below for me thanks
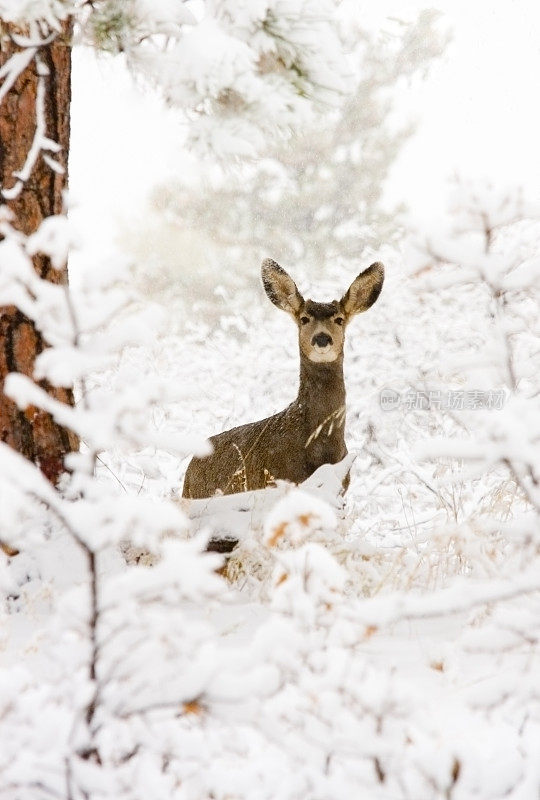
[296,355,345,430]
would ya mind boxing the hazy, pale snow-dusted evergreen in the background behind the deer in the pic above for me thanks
[123,9,446,306]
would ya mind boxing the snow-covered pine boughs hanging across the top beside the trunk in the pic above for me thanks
[0,0,351,160]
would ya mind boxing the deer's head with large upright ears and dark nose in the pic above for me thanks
[261,258,384,363]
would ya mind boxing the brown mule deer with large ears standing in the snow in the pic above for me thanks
[182,259,384,498]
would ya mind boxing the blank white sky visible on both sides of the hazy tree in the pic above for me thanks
[71,0,540,236]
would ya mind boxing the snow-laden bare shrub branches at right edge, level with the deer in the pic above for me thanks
[410,184,540,536]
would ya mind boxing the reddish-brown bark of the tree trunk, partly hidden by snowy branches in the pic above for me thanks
[0,25,78,484]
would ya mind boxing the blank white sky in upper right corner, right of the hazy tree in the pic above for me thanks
[380,0,540,218]
